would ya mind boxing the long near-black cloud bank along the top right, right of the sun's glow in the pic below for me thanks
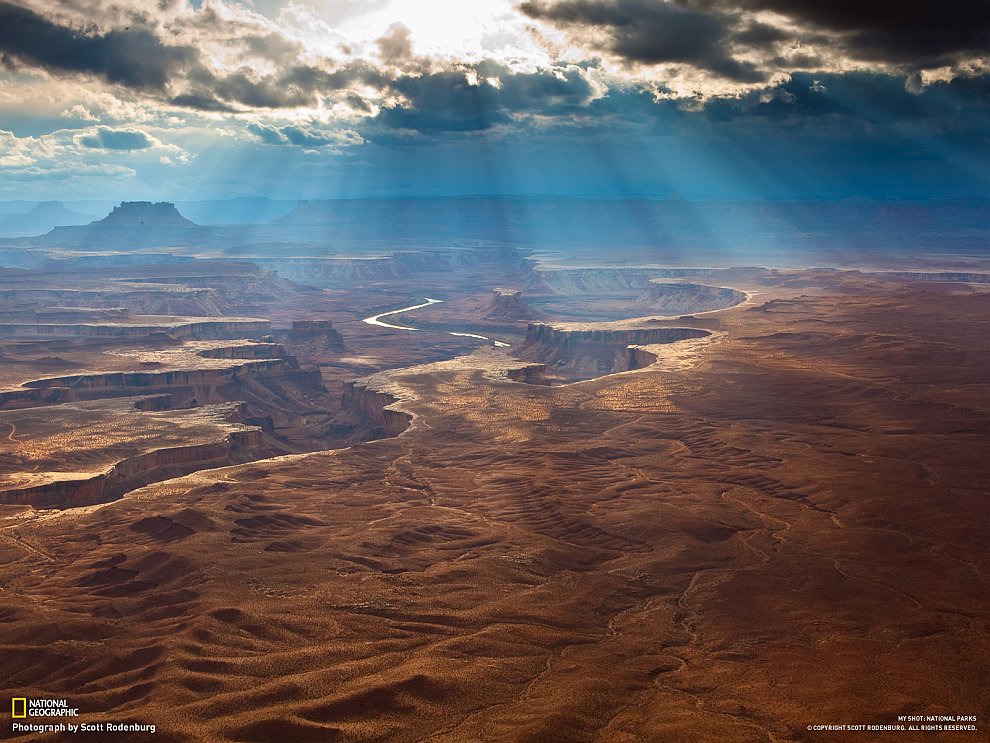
[519,0,990,73]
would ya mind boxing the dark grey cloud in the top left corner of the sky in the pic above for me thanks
[0,2,198,90]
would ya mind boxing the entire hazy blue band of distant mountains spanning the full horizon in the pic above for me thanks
[0,197,990,265]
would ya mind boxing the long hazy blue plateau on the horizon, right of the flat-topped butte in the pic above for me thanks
[273,197,990,255]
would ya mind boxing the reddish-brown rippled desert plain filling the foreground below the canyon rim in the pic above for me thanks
[0,272,990,743]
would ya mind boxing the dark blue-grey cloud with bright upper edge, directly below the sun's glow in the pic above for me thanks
[378,62,595,132]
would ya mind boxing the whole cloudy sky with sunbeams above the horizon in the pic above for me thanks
[0,0,990,201]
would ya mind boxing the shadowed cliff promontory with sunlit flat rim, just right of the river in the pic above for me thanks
[515,323,711,380]
